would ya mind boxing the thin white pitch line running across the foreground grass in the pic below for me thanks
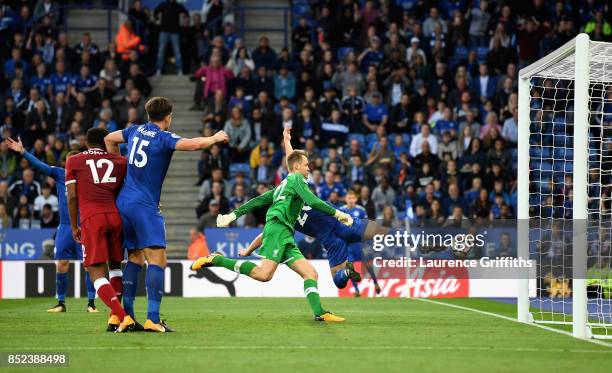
[0,345,612,354]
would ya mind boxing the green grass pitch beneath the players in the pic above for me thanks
[0,298,612,373]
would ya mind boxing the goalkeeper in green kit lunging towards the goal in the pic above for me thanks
[191,150,353,322]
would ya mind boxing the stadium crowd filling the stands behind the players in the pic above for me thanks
[0,0,612,256]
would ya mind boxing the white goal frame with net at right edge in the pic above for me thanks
[518,34,612,338]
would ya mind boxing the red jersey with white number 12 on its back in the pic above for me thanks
[66,149,127,221]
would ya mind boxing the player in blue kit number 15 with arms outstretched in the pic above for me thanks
[104,97,228,332]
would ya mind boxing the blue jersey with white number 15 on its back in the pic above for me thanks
[119,122,181,208]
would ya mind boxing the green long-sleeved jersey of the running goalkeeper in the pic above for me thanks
[234,173,336,232]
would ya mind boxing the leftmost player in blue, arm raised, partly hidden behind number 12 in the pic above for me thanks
[6,138,98,313]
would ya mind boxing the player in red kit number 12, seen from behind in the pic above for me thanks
[66,128,135,332]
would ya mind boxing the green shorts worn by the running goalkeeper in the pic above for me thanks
[259,219,304,267]
